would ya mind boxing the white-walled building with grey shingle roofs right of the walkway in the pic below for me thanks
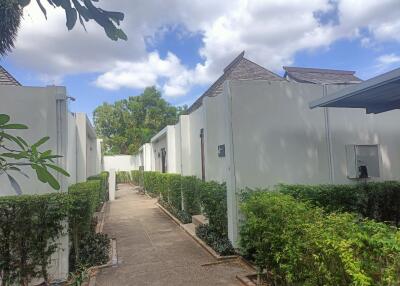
[132,54,400,246]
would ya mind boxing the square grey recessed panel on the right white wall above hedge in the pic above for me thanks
[346,145,380,179]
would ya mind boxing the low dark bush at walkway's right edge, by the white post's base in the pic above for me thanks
[196,224,235,255]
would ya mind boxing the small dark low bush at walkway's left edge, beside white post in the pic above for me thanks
[70,232,110,269]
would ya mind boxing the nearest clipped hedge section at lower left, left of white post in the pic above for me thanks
[0,193,68,286]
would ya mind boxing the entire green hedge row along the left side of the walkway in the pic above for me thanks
[0,173,108,286]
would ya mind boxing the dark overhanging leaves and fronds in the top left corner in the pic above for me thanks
[0,0,127,56]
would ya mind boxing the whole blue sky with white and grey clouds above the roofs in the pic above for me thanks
[0,0,400,114]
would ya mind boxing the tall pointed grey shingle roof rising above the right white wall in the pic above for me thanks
[188,51,285,113]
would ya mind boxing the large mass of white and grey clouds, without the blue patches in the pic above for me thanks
[7,0,400,96]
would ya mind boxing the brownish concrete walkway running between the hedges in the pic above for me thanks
[96,185,247,286]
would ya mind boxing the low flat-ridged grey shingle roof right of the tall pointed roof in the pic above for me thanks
[283,67,362,84]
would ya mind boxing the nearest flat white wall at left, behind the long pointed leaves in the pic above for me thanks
[0,86,73,279]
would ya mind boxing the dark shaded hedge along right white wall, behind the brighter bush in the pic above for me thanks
[277,181,400,226]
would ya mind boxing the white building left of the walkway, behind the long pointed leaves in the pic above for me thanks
[0,67,102,279]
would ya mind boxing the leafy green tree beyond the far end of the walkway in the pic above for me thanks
[93,87,187,154]
